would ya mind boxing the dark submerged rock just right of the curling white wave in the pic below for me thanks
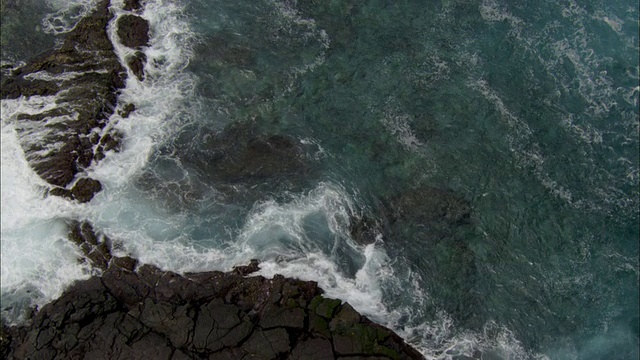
[350,186,483,327]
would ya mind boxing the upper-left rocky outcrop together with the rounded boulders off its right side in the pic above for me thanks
[0,0,149,202]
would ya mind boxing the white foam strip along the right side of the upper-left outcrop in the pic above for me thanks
[92,0,197,188]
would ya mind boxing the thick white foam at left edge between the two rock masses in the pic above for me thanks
[0,117,89,321]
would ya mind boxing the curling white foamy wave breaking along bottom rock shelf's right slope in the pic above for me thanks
[218,183,547,359]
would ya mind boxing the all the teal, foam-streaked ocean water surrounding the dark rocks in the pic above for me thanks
[1,0,640,359]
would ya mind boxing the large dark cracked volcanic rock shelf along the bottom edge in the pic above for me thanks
[5,222,422,359]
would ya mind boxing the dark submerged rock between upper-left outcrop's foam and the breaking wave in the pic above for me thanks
[137,123,313,207]
